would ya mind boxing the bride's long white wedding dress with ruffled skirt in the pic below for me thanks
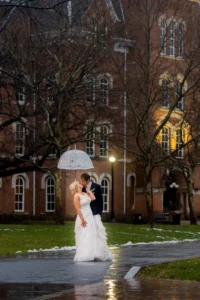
[74,194,112,261]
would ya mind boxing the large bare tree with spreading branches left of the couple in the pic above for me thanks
[0,2,118,223]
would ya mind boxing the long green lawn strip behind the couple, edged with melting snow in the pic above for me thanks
[0,222,200,256]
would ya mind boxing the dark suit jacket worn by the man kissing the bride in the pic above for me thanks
[82,182,103,215]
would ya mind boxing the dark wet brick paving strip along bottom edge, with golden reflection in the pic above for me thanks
[0,279,200,300]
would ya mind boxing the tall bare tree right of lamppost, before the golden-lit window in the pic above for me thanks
[111,0,200,223]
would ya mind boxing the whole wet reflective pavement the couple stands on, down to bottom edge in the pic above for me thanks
[0,242,200,300]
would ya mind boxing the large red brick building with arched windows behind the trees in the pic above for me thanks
[0,0,200,221]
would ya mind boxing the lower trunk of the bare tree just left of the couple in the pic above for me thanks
[55,169,65,225]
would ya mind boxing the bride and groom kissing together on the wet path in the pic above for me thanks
[70,173,112,262]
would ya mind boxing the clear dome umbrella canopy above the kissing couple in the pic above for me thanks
[58,149,94,170]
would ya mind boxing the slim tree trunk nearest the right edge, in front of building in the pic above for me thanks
[186,168,197,225]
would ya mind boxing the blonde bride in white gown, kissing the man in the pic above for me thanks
[70,181,112,261]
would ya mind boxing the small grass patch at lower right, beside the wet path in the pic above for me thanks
[137,258,200,281]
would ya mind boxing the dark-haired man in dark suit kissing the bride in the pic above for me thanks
[81,173,103,216]
